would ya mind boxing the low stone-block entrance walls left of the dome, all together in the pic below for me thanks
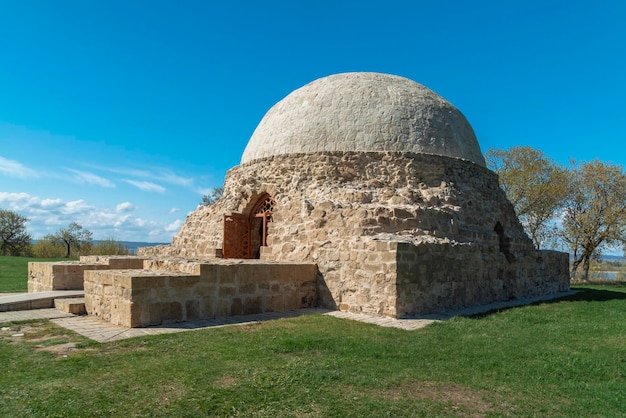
[25,256,318,328]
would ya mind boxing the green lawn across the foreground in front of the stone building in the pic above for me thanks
[0,284,626,417]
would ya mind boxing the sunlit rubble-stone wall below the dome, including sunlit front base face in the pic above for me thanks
[139,152,534,316]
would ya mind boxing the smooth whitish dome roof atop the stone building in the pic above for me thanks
[241,73,485,167]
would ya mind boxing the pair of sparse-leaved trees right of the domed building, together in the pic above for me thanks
[487,147,626,280]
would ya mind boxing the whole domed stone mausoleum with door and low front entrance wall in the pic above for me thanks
[29,73,569,326]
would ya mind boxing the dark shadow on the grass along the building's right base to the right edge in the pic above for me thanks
[466,282,626,319]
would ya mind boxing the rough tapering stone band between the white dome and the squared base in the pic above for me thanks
[140,152,532,257]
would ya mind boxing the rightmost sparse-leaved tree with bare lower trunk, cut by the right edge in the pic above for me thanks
[561,160,626,281]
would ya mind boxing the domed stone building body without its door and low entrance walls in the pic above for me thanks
[141,73,569,316]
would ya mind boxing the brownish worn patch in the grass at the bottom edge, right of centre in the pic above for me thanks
[364,381,499,418]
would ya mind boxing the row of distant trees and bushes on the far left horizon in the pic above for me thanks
[0,216,130,259]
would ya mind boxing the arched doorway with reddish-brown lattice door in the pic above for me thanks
[222,193,276,258]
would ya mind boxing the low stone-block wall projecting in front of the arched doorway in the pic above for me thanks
[85,260,317,327]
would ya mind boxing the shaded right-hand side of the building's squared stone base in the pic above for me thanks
[393,243,570,317]
